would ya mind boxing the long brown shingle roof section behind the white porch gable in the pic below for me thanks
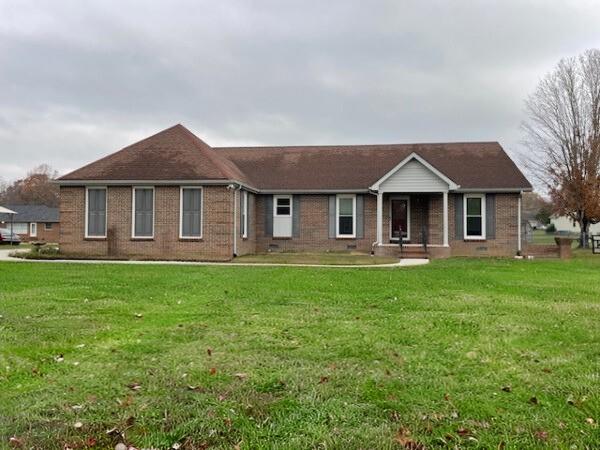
[215,142,531,190]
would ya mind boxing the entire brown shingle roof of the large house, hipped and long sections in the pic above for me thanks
[59,125,531,190]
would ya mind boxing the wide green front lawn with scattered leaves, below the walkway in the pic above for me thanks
[0,257,600,450]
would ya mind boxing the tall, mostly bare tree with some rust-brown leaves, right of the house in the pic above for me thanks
[523,49,600,247]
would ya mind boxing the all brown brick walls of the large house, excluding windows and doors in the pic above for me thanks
[58,186,518,260]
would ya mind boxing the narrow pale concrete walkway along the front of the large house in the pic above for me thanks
[0,247,429,269]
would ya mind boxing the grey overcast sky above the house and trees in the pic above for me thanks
[0,0,600,181]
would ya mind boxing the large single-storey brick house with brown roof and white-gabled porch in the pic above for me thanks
[58,125,531,260]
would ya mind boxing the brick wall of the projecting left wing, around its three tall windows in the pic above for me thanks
[60,186,233,260]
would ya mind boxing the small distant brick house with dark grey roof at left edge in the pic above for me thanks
[0,205,60,243]
